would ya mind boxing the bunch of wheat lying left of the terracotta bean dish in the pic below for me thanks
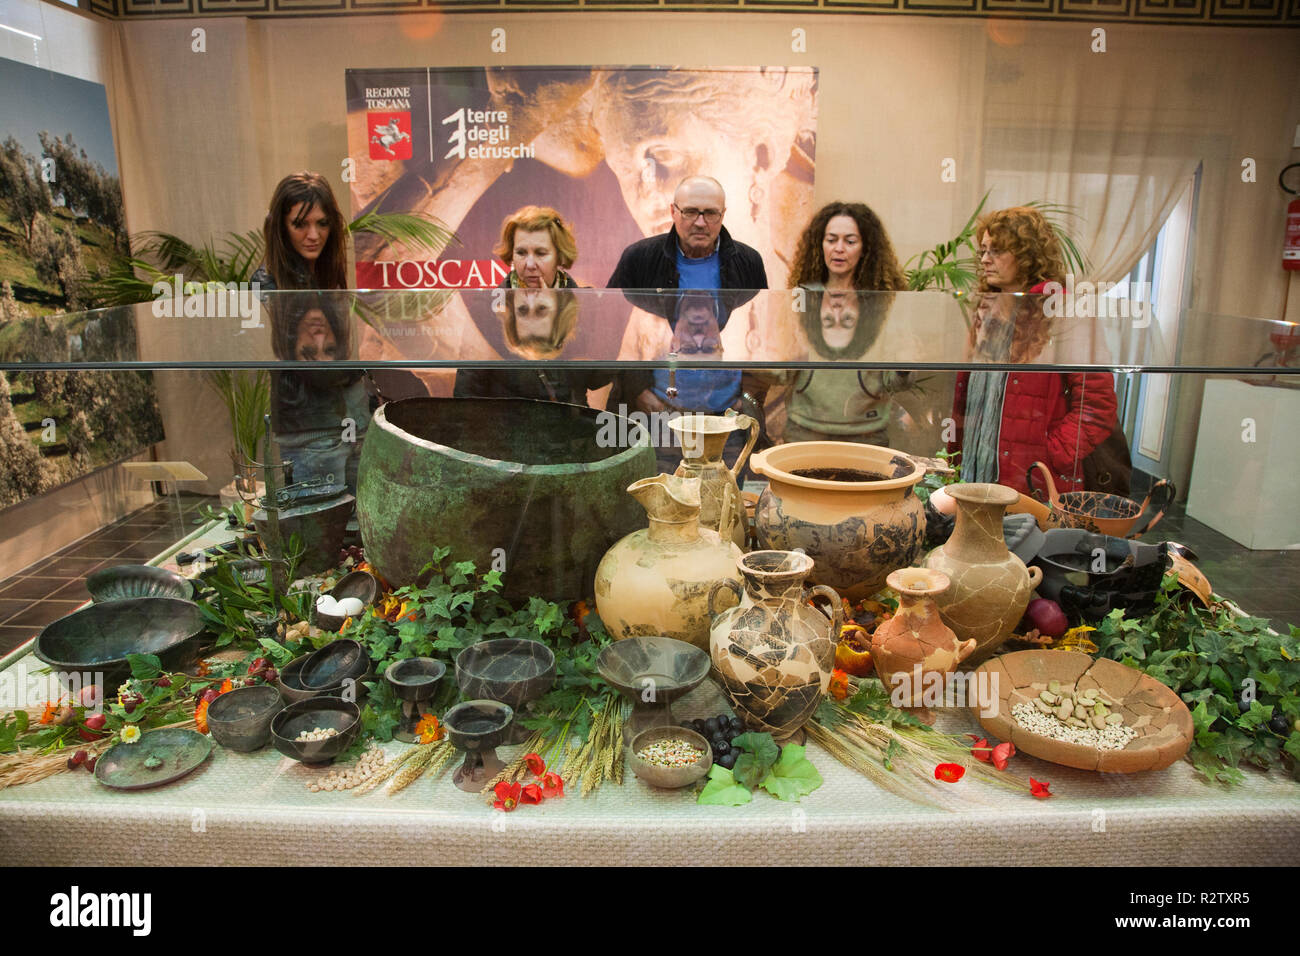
[805,704,1031,809]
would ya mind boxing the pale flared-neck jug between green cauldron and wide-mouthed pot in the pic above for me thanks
[668,412,759,548]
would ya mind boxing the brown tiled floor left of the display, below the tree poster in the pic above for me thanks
[0,494,217,656]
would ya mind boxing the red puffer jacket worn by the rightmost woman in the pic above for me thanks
[948,371,1118,494]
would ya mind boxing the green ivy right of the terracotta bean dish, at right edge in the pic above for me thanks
[1089,575,1300,784]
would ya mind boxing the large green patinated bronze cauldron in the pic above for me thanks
[356,398,657,601]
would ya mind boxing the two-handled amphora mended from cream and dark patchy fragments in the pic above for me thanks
[709,551,844,740]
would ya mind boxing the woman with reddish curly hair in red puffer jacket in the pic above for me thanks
[948,206,1117,494]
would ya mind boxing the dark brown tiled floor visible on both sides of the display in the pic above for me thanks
[0,489,1300,656]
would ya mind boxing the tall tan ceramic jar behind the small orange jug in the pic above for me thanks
[923,483,1043,665]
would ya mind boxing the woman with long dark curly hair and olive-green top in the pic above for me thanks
[761,202,911,445]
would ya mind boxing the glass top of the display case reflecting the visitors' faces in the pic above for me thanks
[0,285,1300,375]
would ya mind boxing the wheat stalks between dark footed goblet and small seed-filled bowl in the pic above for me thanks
[482,692,628,796]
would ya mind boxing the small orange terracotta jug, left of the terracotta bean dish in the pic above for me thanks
[871,567,975,708]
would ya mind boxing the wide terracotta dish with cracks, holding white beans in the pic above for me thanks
[971,650,1193,774]
